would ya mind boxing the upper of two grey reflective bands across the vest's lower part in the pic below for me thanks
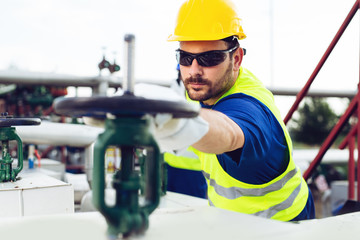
[202,168,298,200]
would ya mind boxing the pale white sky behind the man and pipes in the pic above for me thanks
[0,0,359,115]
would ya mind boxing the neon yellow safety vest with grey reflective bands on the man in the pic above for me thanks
[194,67,309,221]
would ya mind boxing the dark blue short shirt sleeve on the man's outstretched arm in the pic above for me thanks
[213,93,287,184]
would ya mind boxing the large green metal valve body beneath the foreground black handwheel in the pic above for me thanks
[93,116,163,237]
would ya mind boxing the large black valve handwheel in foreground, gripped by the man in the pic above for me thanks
[53,94,199,118]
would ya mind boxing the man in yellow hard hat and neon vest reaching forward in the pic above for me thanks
[168,0,314,221]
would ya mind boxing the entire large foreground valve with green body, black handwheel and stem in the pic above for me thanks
[54,35,198,238]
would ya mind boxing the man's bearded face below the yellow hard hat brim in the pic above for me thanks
[180,40,238,105]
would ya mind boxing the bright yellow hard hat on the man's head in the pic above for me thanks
[168,0,246,41]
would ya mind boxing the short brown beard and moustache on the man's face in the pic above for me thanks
[183,62,234,103]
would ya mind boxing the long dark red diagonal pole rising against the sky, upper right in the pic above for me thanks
[284,0,360,125]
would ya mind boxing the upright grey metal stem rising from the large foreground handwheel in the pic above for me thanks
[123,34,135,94]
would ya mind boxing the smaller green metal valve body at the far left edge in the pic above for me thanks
[0,127,23,182]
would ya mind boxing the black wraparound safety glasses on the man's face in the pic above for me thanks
[176,46,239,67]
